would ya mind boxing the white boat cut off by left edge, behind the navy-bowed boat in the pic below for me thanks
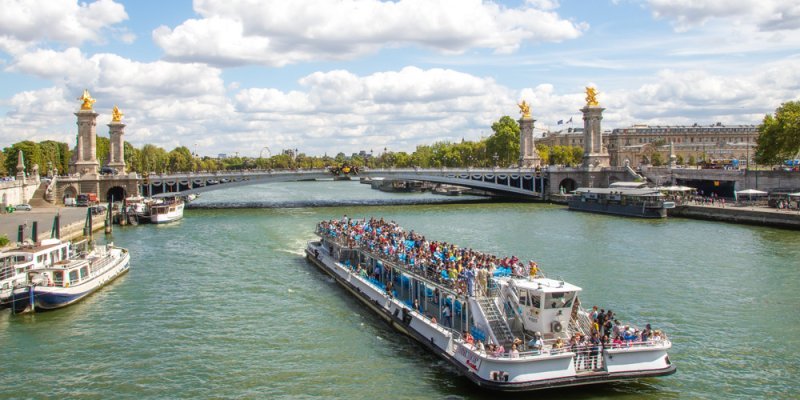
[0,239,73,308]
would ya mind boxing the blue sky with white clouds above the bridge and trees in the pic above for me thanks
[0,0,800,157]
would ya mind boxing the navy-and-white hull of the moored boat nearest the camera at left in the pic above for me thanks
[10,252,130,314]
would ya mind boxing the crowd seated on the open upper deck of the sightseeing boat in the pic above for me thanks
[318,215,539,296]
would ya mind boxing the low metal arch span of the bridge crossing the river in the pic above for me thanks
[140,168,548,200]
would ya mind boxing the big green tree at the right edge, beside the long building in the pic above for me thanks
[755,101,800,164]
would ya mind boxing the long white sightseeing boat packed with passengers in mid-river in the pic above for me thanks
[306,219,676,392]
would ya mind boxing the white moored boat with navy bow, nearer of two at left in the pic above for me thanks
[11,244,130,314]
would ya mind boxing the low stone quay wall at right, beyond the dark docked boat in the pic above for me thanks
[668,205,800,229]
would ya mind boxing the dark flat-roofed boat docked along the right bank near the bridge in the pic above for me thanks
[569,187,675,218]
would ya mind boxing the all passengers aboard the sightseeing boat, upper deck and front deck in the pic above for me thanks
[317,215,665,360]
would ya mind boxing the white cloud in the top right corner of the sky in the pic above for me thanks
[647,0,800,32]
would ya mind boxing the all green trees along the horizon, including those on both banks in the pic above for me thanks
[10,101,800,176]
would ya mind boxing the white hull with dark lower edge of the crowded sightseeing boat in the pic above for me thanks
[306,247,676,392]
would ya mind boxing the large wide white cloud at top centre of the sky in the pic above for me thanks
[153,0,588,66]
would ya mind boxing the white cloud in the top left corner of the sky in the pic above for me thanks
[0,0,128,52]
